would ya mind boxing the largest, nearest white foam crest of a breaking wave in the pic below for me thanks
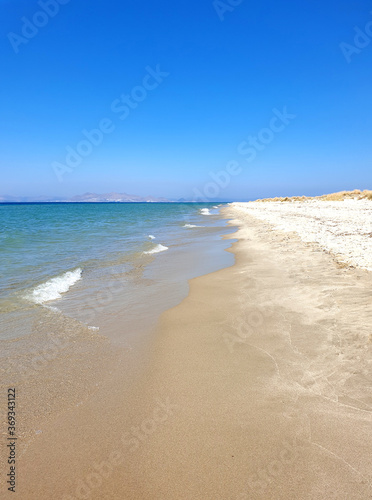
[26,267,82,304]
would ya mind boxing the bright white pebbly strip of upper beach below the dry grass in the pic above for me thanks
[232,200,372,271]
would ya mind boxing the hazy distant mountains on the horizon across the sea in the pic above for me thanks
[0,193,170,203]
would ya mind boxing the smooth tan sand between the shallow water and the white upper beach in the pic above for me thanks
[1,206,372,500]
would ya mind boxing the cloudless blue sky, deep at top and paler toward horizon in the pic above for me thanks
[0,0,372,200]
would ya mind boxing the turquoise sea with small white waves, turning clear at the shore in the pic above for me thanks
[0,203,233,342]
